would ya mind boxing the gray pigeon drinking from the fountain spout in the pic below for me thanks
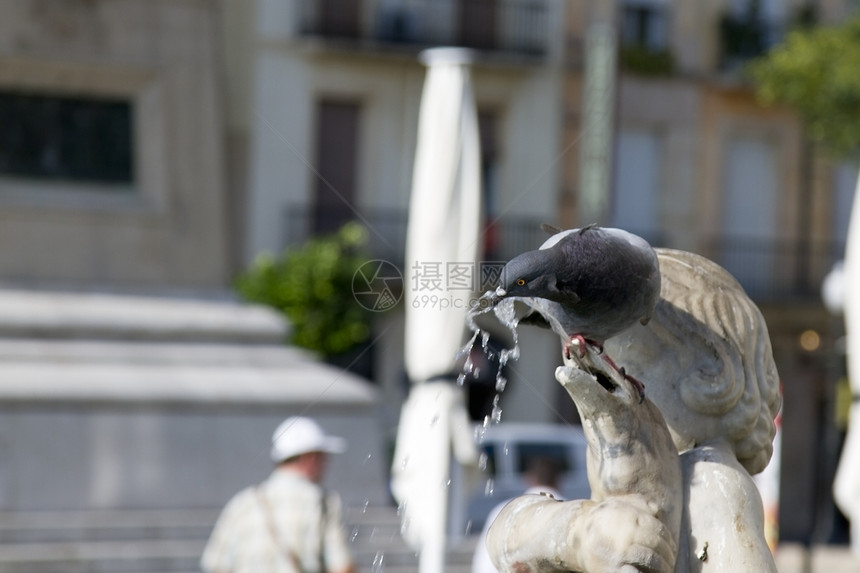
[495,225,660,398]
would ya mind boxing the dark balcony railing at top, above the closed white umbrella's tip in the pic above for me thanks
[293,0,549,57]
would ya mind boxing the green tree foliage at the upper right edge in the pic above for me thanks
[749,16,860,155]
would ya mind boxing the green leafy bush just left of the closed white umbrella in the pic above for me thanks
[236,223,370,356]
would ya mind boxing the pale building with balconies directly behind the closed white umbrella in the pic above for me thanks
[233,0,565,438]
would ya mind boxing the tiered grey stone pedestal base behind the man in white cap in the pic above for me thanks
[0,290,388,571]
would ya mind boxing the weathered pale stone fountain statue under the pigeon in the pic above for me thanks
[488,249,781,573]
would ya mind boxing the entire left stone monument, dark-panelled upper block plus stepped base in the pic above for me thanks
[0,0,388,573]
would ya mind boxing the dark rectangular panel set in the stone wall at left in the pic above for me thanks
[0,91,134,183]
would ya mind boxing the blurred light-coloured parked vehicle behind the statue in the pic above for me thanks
[452,422,591,534]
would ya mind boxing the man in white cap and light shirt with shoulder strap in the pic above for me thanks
[200,416,356,573]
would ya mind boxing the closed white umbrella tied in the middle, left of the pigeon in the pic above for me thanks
[392,48,481,573]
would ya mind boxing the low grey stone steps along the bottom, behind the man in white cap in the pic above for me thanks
[0,507,475,573]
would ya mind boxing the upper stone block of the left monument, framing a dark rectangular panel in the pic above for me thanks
[0,1,230,289]
